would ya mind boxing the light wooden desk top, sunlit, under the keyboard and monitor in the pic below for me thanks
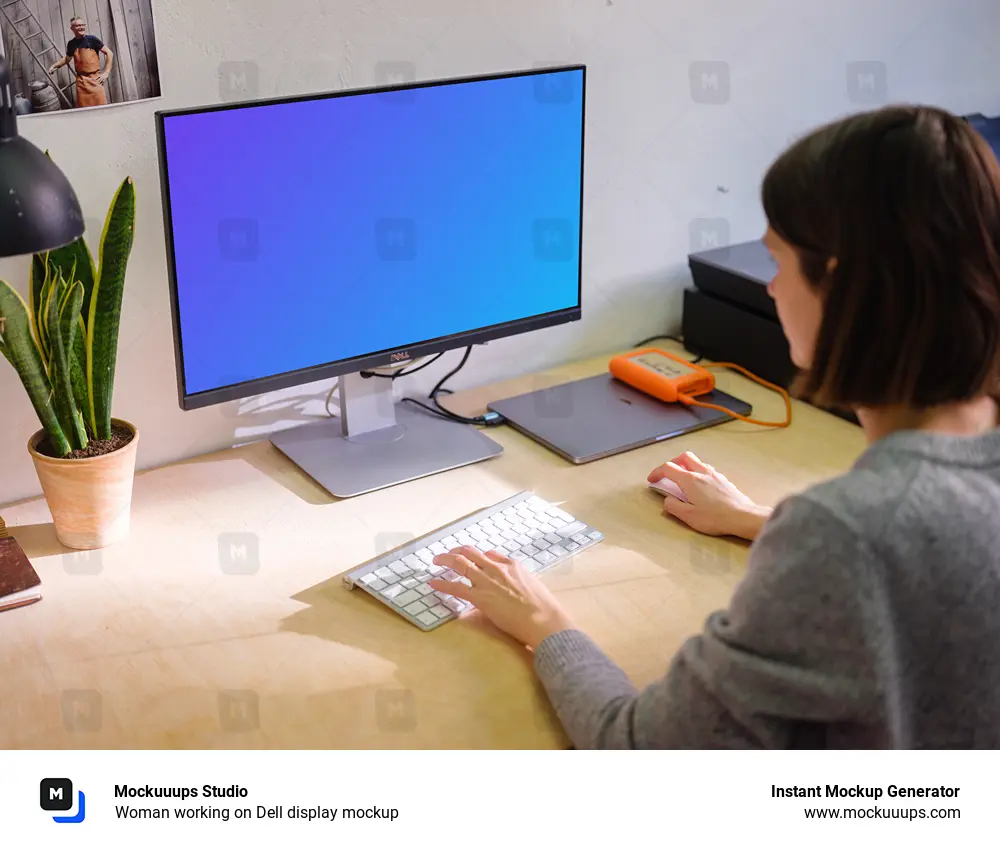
[0,344,864,749]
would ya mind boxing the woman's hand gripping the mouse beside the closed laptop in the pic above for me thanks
[648,452,771,540]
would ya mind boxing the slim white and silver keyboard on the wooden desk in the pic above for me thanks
[344,492,604,631]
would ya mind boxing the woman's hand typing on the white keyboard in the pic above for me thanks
[428,546,574,649]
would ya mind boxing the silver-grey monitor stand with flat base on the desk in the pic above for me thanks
[271,373,503,499]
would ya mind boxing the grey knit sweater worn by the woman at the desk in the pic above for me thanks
[534,430,1000,749]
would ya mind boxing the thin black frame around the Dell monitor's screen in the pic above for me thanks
[155,64,587,410]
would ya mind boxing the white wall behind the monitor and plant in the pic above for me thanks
[0,0,1000,503]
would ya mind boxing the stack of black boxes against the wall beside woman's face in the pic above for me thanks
[682,239,858,424]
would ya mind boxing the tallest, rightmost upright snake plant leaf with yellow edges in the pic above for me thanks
[85,177,135,440]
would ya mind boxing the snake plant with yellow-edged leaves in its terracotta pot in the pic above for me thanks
[0,177,139,549]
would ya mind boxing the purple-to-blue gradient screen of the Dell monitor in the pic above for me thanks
[163,69,584,395]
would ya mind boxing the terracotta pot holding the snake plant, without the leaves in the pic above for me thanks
[28,419,139,549]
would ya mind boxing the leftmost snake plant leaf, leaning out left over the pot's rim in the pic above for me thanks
[0,281,72,457]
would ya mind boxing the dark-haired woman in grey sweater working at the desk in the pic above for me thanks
[433,102,1000,748]
